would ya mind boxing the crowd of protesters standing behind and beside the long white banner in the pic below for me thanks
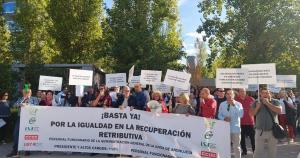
[0,84,300,158]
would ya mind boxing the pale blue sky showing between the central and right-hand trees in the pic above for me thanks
[104,0,203,59]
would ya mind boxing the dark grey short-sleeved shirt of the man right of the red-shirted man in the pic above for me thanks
[251,99,280,131]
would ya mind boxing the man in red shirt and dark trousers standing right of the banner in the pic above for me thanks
[236,88,255,155]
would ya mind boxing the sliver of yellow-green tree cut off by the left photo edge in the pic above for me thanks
[0,5,12,64]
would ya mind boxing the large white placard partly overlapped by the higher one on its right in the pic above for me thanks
[216,69,248,88]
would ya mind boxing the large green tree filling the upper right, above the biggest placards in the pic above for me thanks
[198,0,300,74]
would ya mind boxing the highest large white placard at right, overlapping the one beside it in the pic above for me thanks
[242,63,277,84]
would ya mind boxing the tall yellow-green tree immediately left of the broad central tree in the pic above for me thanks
[48,0,105,63]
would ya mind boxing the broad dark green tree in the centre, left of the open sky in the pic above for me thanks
[107,0,184,72]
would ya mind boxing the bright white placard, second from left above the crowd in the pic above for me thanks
[69,69,93,86]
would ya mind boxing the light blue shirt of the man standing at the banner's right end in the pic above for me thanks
[218,100,244,133]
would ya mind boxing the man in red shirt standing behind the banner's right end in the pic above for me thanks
[198,88,217,119]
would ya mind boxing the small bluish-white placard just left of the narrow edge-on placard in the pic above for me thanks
[105,73,127,88]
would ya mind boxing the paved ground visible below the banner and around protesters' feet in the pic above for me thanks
[0,138,300,158]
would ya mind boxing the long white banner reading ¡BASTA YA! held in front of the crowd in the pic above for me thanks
[19,106,230,158]
